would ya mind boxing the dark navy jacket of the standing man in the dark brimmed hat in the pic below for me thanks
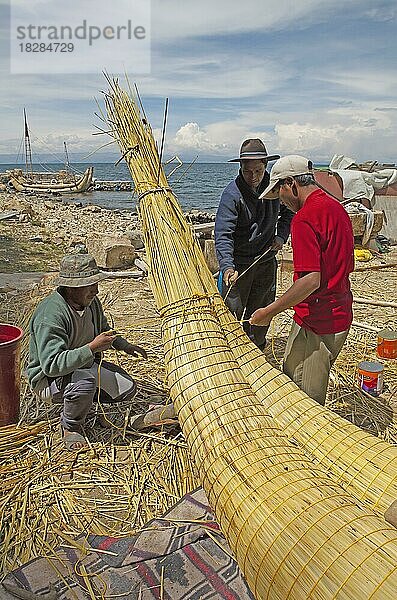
[215,172,293,271]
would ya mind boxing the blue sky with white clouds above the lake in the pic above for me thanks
[0,0,397,162]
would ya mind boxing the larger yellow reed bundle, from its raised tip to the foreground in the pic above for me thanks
[106,80,397,600]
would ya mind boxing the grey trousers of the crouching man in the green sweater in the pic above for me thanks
[34,361,136,431]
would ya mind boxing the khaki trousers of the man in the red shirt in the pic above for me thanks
[283,321,349,406]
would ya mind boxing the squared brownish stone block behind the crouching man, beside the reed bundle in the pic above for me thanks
[86,233,136,269]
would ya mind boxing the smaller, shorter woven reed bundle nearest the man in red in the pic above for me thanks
[216,299,397,514]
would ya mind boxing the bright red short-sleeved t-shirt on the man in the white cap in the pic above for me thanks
[291,190,354,335]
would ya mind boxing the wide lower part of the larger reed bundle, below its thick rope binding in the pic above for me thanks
[163,299,397,598]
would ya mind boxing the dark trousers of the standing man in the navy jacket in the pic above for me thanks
[222,257,277,349]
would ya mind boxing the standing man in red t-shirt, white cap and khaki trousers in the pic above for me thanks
[250,155,354,404]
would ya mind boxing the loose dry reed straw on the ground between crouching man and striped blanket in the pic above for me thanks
[0,423,197,574]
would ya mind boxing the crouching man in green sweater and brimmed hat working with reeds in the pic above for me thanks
[27,254,147,450]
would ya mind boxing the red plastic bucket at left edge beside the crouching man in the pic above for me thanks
[0,323,23,427]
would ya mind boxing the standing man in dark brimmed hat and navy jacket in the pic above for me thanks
[215,139,293,349]
